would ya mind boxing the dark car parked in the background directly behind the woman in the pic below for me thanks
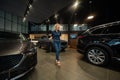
[38,36,68,52]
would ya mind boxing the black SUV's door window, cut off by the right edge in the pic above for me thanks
[105,25,120,34]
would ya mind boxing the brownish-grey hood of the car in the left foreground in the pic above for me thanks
[0,40,27,56]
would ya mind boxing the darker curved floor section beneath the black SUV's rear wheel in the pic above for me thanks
[78,58,120,80]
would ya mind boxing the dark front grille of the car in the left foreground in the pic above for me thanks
[0,54,23,72]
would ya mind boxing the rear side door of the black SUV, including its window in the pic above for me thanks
[104,24,120,57]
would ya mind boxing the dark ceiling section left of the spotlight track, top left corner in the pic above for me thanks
[0,0,28,16]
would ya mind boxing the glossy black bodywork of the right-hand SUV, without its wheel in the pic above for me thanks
[77,21,120,64]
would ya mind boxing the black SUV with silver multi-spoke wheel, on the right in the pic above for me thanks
[77,21,120,66]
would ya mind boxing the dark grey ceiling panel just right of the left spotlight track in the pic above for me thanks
[28,0,73,23]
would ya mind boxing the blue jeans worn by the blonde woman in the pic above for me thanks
[53,41,61,60]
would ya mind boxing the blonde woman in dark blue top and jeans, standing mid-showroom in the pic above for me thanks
[52,23,61,65]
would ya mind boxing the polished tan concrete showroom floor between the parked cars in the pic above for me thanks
[20,48,120,80]
